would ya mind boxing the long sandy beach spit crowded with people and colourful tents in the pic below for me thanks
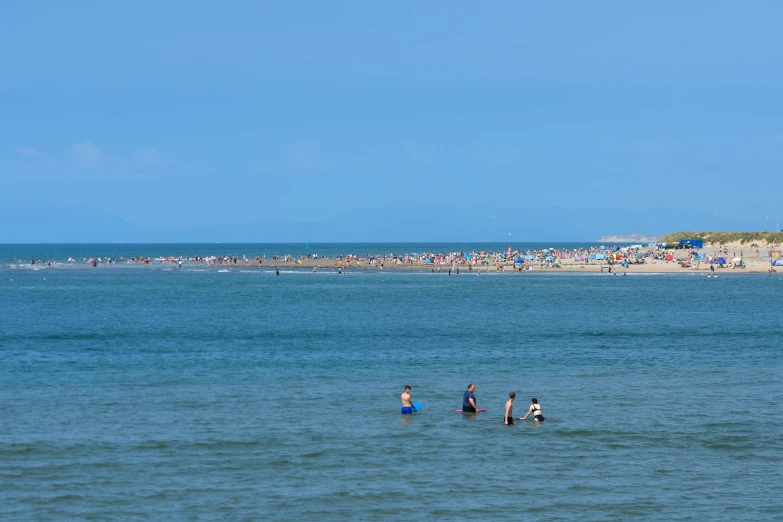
[15,242,781,275]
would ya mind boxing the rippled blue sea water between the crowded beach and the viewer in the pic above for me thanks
[0,245,783,520]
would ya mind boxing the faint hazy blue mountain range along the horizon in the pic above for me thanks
[0,199,768,245]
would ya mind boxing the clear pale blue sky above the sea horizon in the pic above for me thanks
[0,1,783,242]
